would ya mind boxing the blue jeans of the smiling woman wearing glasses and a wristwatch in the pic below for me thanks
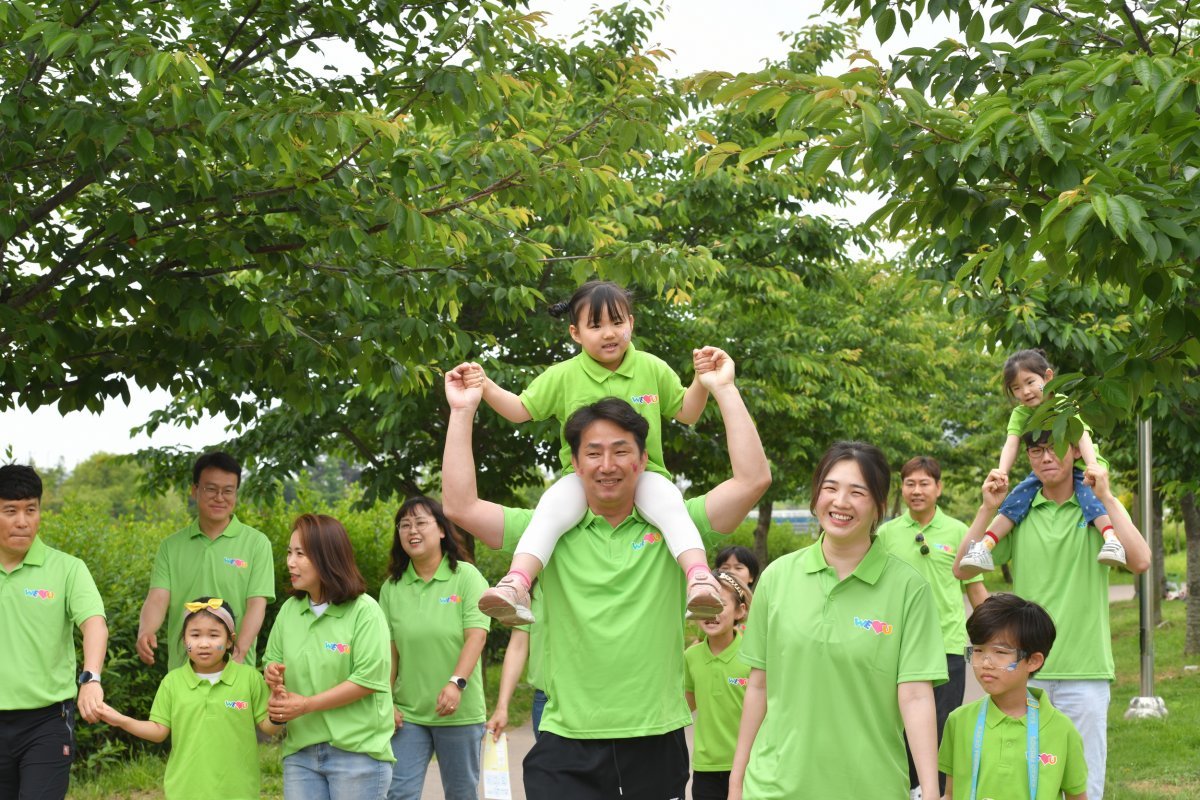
[388,722,484,800]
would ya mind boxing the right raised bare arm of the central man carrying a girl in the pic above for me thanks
[698,348,770,534]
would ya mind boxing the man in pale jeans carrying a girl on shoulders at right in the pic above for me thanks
[954,432,1150,800]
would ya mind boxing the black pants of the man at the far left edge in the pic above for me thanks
[0,700,74,800]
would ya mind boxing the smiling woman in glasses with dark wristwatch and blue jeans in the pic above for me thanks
[379,497,491,800]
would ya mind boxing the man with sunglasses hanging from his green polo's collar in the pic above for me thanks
[876,456,988,796]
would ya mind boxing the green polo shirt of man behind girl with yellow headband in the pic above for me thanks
[150,517,275,669]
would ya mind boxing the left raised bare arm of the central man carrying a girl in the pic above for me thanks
[442,363,504,549]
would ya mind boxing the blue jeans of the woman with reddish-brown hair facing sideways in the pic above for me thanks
[283,742,391,800]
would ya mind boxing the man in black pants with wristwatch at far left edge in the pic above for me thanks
[0,464,108,800]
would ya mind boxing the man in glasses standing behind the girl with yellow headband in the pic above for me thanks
[137,452,275,669]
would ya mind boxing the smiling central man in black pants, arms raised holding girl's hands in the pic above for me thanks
[442,348,770,800]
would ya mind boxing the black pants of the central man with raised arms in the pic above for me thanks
[524,728,689,800]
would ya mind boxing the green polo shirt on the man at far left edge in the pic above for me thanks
[0,536,104,711]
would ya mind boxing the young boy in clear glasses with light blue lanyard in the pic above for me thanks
[937,594,1087,800]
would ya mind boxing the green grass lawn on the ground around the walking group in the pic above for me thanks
[67,594,1200,800]
